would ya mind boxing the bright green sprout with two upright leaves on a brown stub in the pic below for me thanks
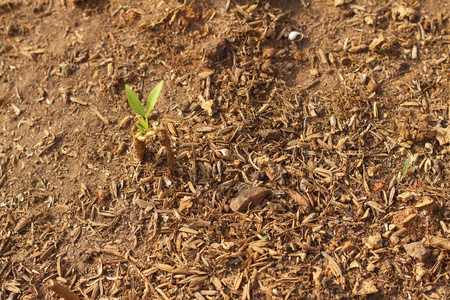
[125,80,164,140]
